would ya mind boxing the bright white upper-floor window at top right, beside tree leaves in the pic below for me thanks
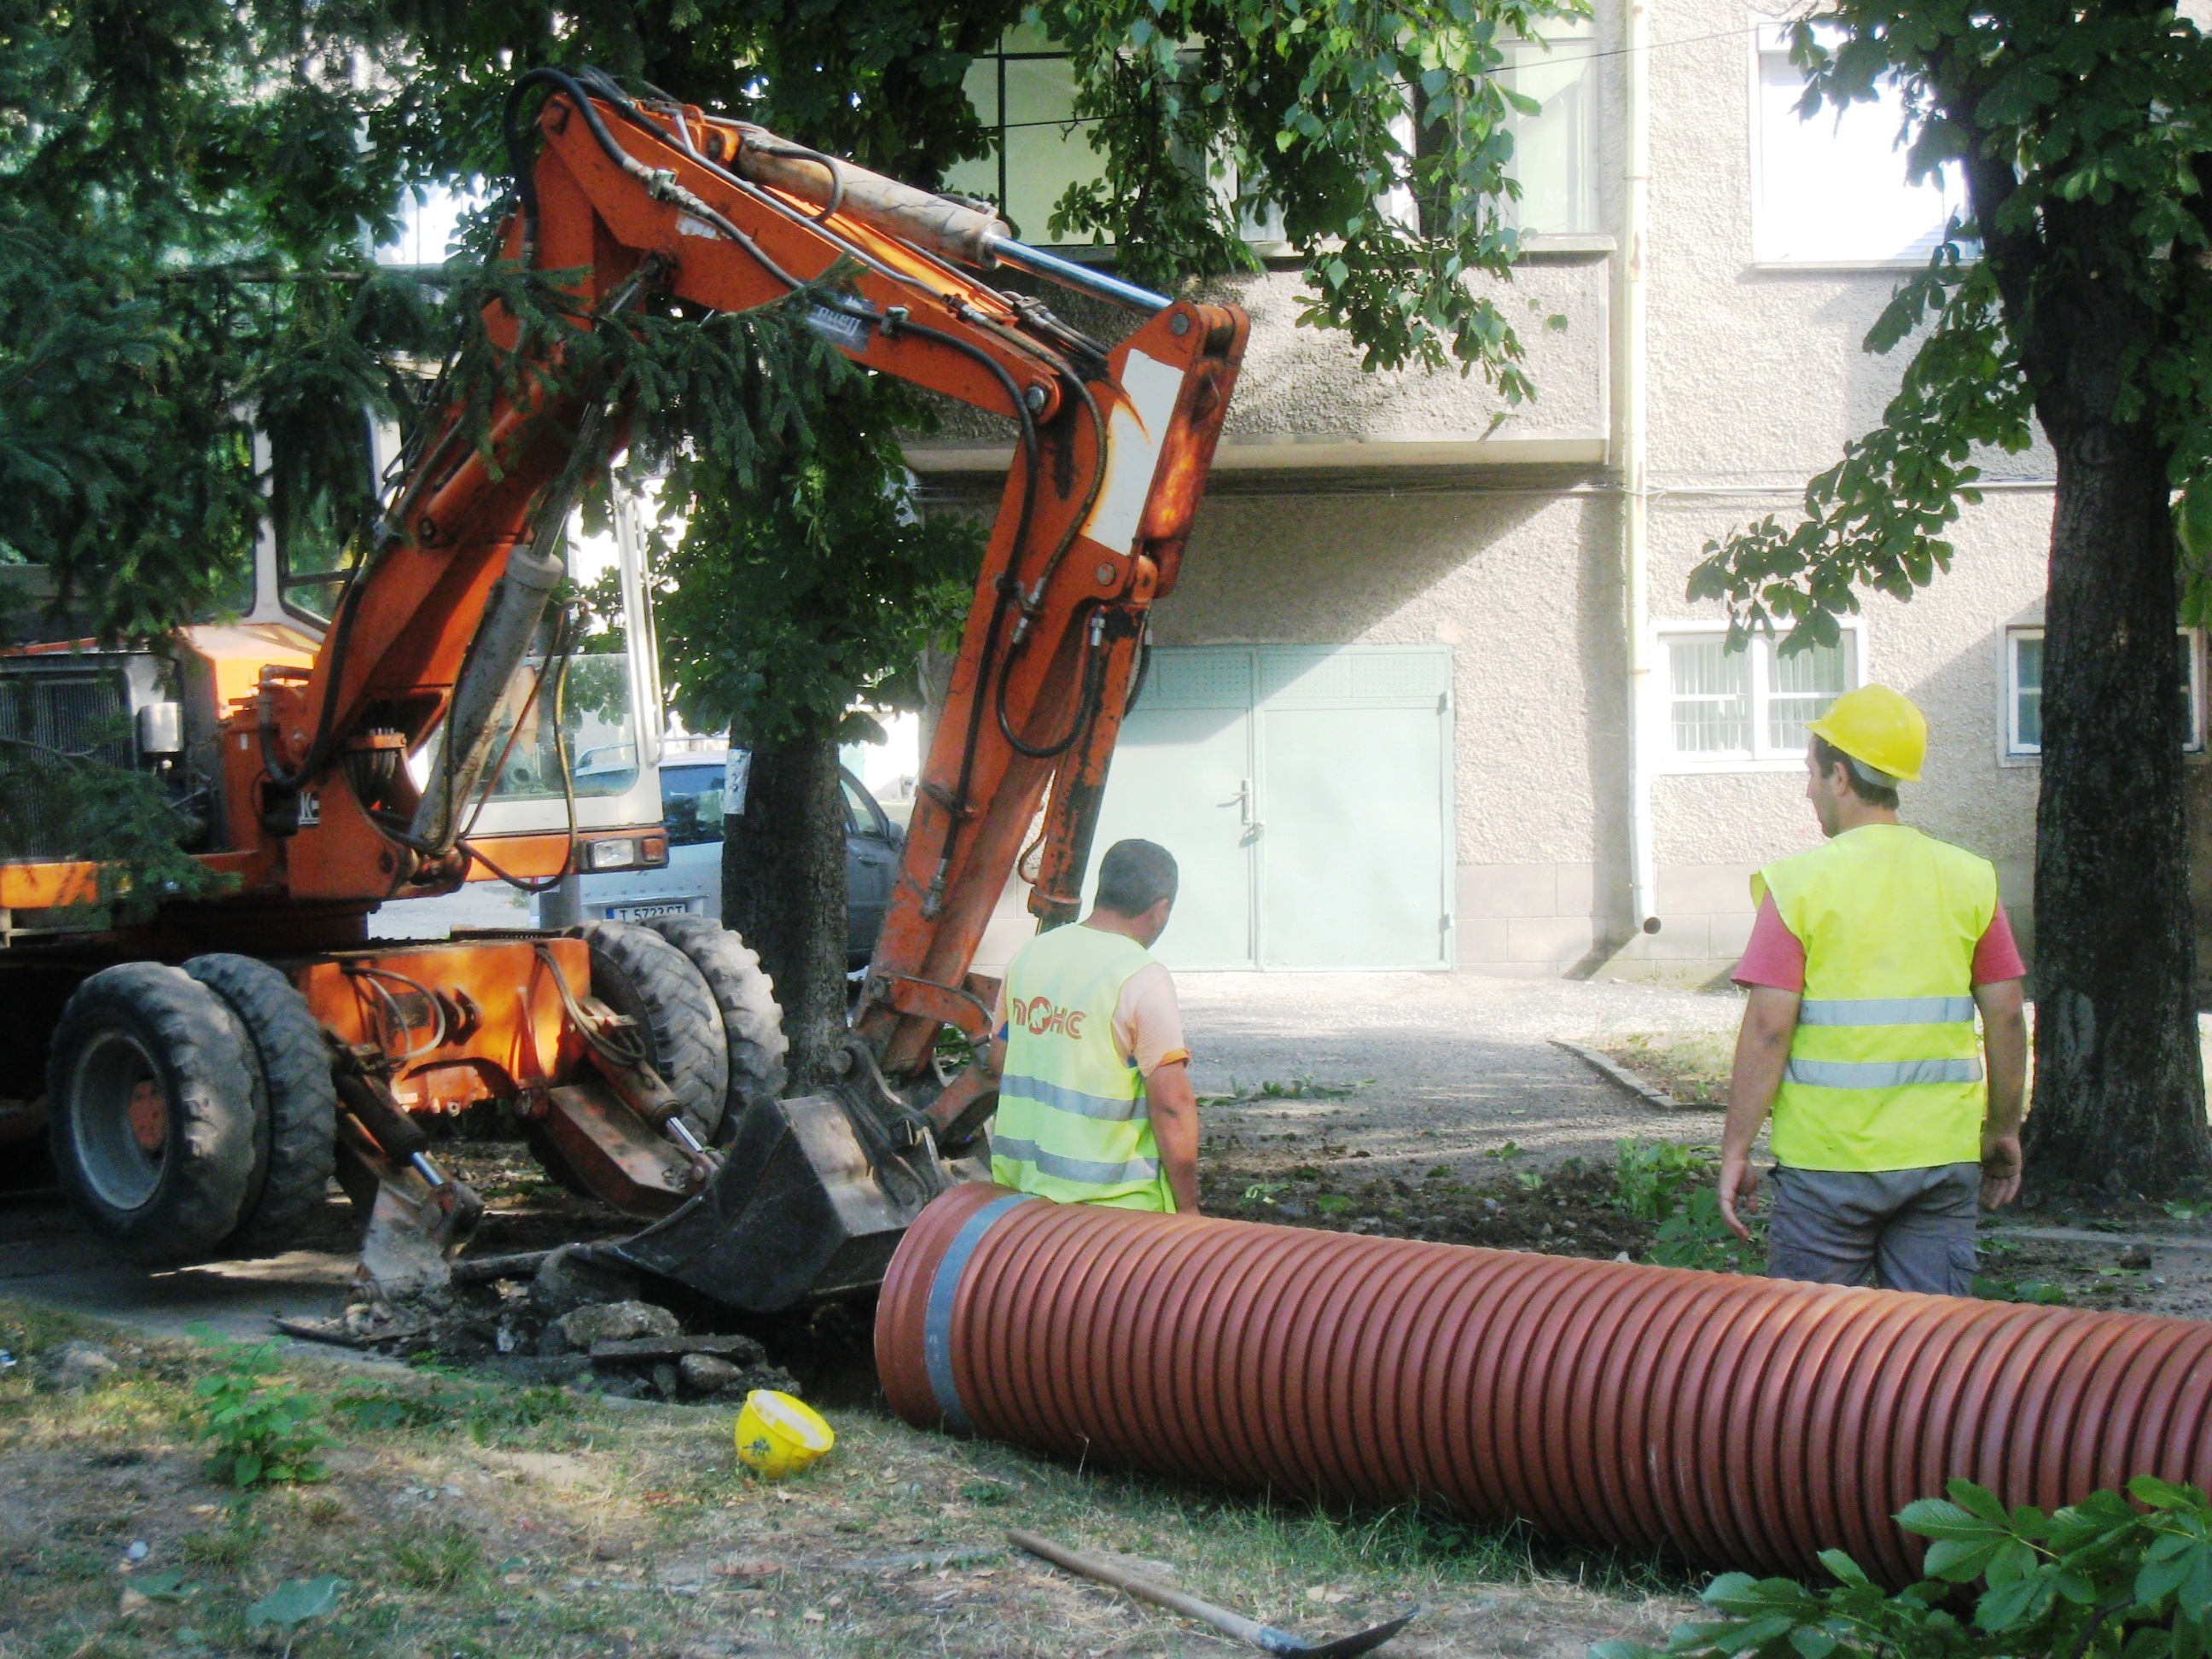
[1752,22,1966,265]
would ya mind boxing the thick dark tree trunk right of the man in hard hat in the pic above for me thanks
[2026,276,2212,1196]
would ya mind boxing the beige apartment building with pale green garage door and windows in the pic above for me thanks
[911,0,2158,982]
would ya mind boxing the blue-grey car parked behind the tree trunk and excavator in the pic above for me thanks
[578,750,905,969]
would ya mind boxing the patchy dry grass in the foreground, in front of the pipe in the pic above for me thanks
[0,1303,1688,1659]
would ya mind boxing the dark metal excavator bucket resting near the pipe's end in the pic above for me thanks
[608,1086,989,1314]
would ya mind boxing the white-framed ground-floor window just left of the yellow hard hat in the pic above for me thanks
[1659,628,1858,772]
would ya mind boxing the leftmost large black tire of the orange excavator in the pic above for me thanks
[46,963,257,1266]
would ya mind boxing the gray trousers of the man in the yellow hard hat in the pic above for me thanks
[1767,1163,1982,1296]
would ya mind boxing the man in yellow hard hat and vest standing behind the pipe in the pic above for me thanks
[1721,686,2029,1296]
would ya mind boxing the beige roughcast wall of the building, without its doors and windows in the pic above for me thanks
[918,0,2061,982]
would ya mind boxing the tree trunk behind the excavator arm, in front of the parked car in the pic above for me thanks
[721,735,845,1095]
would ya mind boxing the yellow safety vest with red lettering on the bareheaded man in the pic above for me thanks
[991,924,1174,1210]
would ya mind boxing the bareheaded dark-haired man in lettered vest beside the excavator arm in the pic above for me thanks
[991,841,1199,1214]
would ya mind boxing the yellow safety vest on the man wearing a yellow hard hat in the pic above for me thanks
[1752,823,1998,1170]
